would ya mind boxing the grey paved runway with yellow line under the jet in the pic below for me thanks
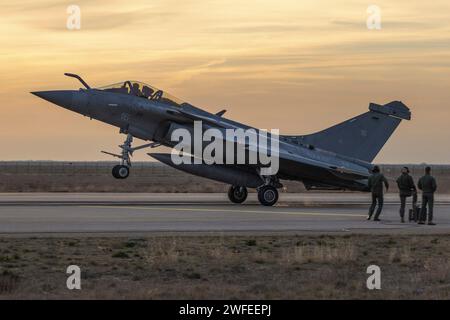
[0,193,450,234]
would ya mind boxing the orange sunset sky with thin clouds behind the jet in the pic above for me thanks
[0,0,450,163]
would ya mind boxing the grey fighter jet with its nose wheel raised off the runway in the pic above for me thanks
[32,74,411,206]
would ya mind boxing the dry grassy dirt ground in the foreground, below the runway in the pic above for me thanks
[0,234,450,299]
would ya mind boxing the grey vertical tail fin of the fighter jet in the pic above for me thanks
[296,101,411,162]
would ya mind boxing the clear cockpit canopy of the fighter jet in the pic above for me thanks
[97,80,185,107]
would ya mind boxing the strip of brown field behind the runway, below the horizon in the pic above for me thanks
[0,161,450,194]
